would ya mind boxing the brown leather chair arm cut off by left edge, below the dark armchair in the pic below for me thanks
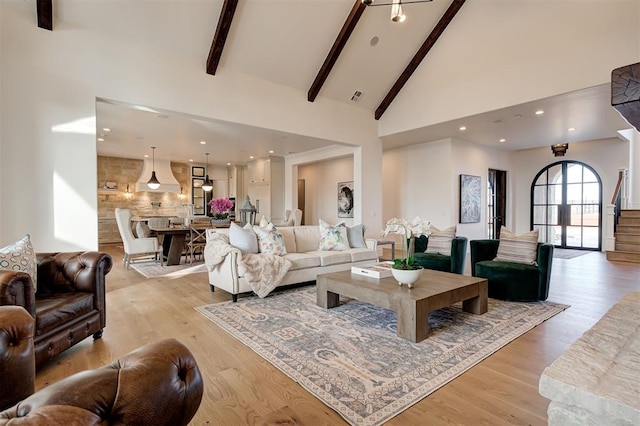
[0,306,36,410]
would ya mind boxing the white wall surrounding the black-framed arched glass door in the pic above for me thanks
[507,138,629,243]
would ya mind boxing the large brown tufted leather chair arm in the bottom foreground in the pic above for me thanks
[0,339,203,425]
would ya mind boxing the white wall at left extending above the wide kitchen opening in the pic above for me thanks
[0,1,381,251]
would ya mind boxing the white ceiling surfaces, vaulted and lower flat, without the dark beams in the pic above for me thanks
[51,0,630,164]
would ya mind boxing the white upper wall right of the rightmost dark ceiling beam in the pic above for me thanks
[379,0,640,136]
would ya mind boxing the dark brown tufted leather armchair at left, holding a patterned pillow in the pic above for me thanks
[0,251,113,367]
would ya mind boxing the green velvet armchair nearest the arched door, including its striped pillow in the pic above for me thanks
[470,227,554,302]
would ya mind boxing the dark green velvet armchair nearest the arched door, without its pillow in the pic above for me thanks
[469,240,553,302]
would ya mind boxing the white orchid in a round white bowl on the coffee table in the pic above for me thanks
[382,216,431,288]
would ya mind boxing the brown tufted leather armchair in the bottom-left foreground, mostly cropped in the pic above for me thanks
[0,306,203,426]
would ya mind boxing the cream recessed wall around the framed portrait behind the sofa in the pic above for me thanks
[298,156,359,226]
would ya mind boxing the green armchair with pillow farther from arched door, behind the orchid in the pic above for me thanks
[414,226,468,275]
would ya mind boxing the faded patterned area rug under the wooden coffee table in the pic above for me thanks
[195,286,568,425]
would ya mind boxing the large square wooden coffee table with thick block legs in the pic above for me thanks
[316,269,488,342]
